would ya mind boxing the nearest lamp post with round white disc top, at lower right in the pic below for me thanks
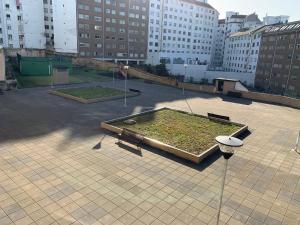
[216,136,243,225]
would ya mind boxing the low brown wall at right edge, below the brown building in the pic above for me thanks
[241,91,300,109]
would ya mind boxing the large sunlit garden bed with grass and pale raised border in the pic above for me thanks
[102,108,247,162]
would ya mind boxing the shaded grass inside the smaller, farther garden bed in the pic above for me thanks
[56,87,124,100]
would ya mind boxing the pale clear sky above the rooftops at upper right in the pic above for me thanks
[208,0,300,22]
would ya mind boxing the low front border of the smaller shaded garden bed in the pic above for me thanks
[49,90,140,104]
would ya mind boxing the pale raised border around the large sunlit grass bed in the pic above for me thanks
[101,108,248,163]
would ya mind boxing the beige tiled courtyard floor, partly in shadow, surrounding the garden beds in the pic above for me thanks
[0,81,300,225]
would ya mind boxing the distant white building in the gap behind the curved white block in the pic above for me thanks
[210,11,262,67]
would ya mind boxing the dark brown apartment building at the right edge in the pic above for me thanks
[255,22,300,97]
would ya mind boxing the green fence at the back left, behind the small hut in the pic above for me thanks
[18,56,72,76]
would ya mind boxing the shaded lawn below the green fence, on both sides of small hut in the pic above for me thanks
[17,68,112,88]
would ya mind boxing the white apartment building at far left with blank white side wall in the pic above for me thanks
[0,0,77,53]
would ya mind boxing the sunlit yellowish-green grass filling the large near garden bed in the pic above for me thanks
[112,109,241,155]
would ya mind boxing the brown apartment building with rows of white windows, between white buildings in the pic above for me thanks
[77,0,149,63]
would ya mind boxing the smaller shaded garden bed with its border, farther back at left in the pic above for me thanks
[50,86,138,103]
